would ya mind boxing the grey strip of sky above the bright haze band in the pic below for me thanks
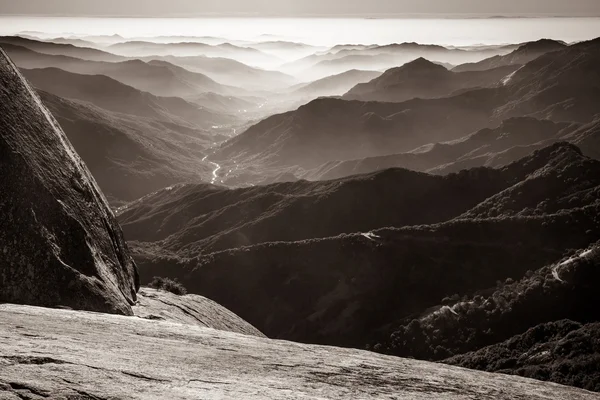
[0,0,600,16]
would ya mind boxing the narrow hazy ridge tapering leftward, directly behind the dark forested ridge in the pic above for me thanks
[302,117,600,180]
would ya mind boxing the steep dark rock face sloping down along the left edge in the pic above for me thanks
[0,50,139,314]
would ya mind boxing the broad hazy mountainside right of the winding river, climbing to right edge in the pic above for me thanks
[216,40,600,169]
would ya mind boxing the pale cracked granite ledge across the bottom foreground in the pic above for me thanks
[0,304,598,400]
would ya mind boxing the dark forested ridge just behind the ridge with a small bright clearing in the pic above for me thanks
[119,144,584,255]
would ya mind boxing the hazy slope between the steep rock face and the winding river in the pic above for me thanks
[41,92,219,205]
